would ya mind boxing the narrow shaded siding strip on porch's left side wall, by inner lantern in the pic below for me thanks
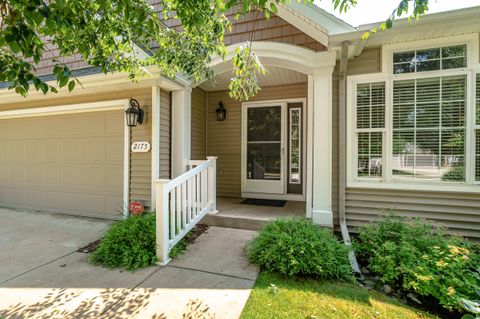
[190,88,207,160]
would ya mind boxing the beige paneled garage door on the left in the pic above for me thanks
[0,110,124,218]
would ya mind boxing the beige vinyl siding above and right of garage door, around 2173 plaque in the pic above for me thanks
[0,88,171,215]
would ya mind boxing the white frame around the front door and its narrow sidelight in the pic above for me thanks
[240,98,308,201]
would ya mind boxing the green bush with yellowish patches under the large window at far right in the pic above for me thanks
[354,216,480,310]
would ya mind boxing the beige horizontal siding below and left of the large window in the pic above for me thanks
[333,49,480,237]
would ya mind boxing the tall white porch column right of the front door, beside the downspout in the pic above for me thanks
[309,65,334,227]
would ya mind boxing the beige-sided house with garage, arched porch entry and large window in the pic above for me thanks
[0,1,480,248]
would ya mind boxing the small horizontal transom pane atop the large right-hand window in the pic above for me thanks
[393,45,467,74]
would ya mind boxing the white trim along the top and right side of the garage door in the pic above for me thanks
[0,99,130,217]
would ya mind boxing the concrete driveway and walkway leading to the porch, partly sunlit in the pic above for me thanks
[0,209,258,319]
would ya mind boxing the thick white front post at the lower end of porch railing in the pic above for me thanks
[156,181,170,265]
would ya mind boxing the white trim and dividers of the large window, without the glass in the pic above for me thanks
[346,33,480,193]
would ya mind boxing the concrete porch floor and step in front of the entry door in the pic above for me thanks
[201,196,305,230]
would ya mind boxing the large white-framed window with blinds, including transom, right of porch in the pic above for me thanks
[347,36,480,190]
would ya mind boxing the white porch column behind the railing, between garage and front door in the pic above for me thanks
[171,87,192,178]
